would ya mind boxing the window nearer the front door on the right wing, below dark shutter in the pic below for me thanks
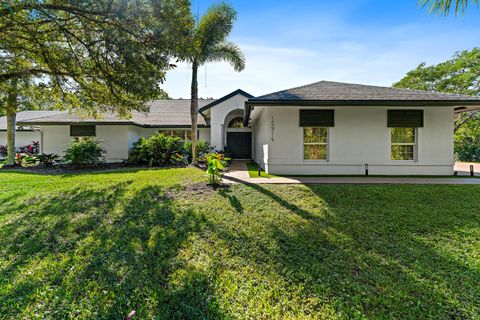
[303,127,328,160]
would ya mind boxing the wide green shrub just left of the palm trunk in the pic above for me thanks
[128,133,182,166]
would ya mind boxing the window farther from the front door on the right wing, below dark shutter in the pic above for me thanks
[391,128,416,160]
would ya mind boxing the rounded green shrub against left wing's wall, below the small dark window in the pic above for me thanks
[63,138,105,164]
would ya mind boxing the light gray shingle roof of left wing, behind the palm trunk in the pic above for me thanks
[19,99,214,127]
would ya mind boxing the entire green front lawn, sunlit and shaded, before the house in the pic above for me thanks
[0,169,480,319]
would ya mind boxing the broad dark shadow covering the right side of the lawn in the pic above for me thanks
[216,184,480,319]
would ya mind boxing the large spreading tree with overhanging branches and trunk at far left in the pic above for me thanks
[0,0,190,163]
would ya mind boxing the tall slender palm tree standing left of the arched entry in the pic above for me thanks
[181,2,245,163]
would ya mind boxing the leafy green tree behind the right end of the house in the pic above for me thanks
[393,48,480,131]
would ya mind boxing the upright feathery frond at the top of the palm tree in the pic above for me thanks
[194,2,237,56]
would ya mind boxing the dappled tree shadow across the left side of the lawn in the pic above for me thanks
[0,183,223,319]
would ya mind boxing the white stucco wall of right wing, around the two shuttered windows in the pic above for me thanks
[255,106,454,175]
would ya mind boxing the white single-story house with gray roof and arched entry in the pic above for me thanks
[0,81,480,175]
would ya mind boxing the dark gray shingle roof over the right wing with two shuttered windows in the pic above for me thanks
[249,81,480,104]
